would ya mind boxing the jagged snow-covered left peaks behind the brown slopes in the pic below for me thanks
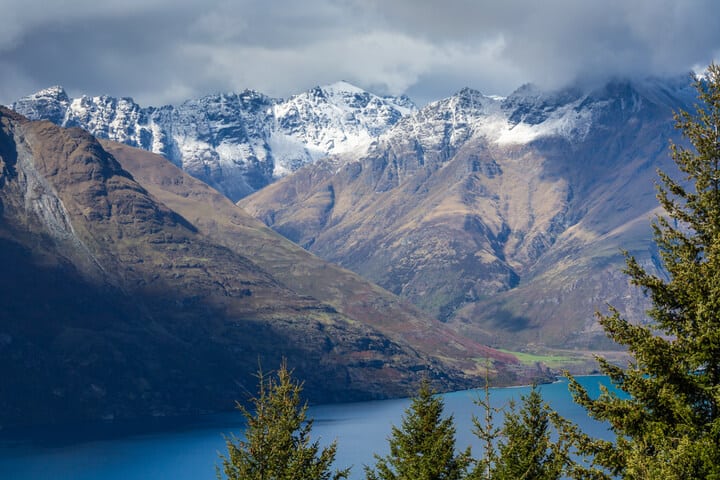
[11,82,415,200]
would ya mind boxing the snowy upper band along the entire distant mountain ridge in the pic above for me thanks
[13,78,692,200]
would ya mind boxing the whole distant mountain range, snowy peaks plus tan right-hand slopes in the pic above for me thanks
[12,77,695,384]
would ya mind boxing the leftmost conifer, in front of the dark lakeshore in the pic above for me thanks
[217,361,348,480]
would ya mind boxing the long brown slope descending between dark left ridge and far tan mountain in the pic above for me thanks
[102,141,514,375]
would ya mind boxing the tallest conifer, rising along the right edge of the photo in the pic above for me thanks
[571,64,720,479]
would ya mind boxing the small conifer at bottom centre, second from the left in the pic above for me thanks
[365,379,470,480]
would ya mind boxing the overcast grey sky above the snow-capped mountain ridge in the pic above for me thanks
[0,0,720,106]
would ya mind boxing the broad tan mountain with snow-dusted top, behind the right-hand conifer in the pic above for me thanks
[239,79,694,348]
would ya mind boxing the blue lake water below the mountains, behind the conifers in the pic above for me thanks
[0,376,611,480]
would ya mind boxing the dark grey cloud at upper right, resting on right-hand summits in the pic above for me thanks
[362,0,720,92]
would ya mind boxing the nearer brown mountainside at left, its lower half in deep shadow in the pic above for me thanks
[0,107,515,425]
